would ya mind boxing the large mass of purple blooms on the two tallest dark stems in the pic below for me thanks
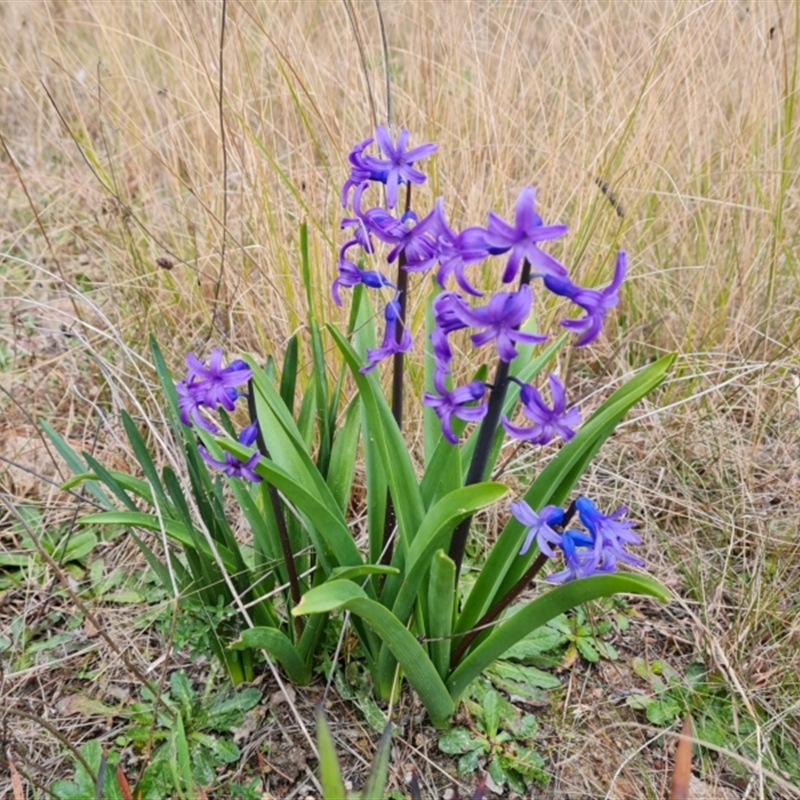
[332,126,627,444]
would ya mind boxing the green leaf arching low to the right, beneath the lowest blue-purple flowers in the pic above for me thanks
[447,572,670,702]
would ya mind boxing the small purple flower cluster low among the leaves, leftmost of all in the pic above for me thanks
[175,347,261,483]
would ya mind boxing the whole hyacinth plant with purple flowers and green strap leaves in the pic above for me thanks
[53,127,673,726]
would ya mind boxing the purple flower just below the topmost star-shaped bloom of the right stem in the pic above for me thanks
[455,284,547,361]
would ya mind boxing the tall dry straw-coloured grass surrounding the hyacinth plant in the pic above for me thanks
[0,0,800,797]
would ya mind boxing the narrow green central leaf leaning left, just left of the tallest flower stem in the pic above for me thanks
[328,325,424,545]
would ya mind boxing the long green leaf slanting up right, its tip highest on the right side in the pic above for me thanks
[456,355,675,638]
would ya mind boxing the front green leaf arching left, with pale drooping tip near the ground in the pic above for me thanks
[292,581,454,727]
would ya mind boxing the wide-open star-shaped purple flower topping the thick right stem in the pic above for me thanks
[486,186,569,283]
